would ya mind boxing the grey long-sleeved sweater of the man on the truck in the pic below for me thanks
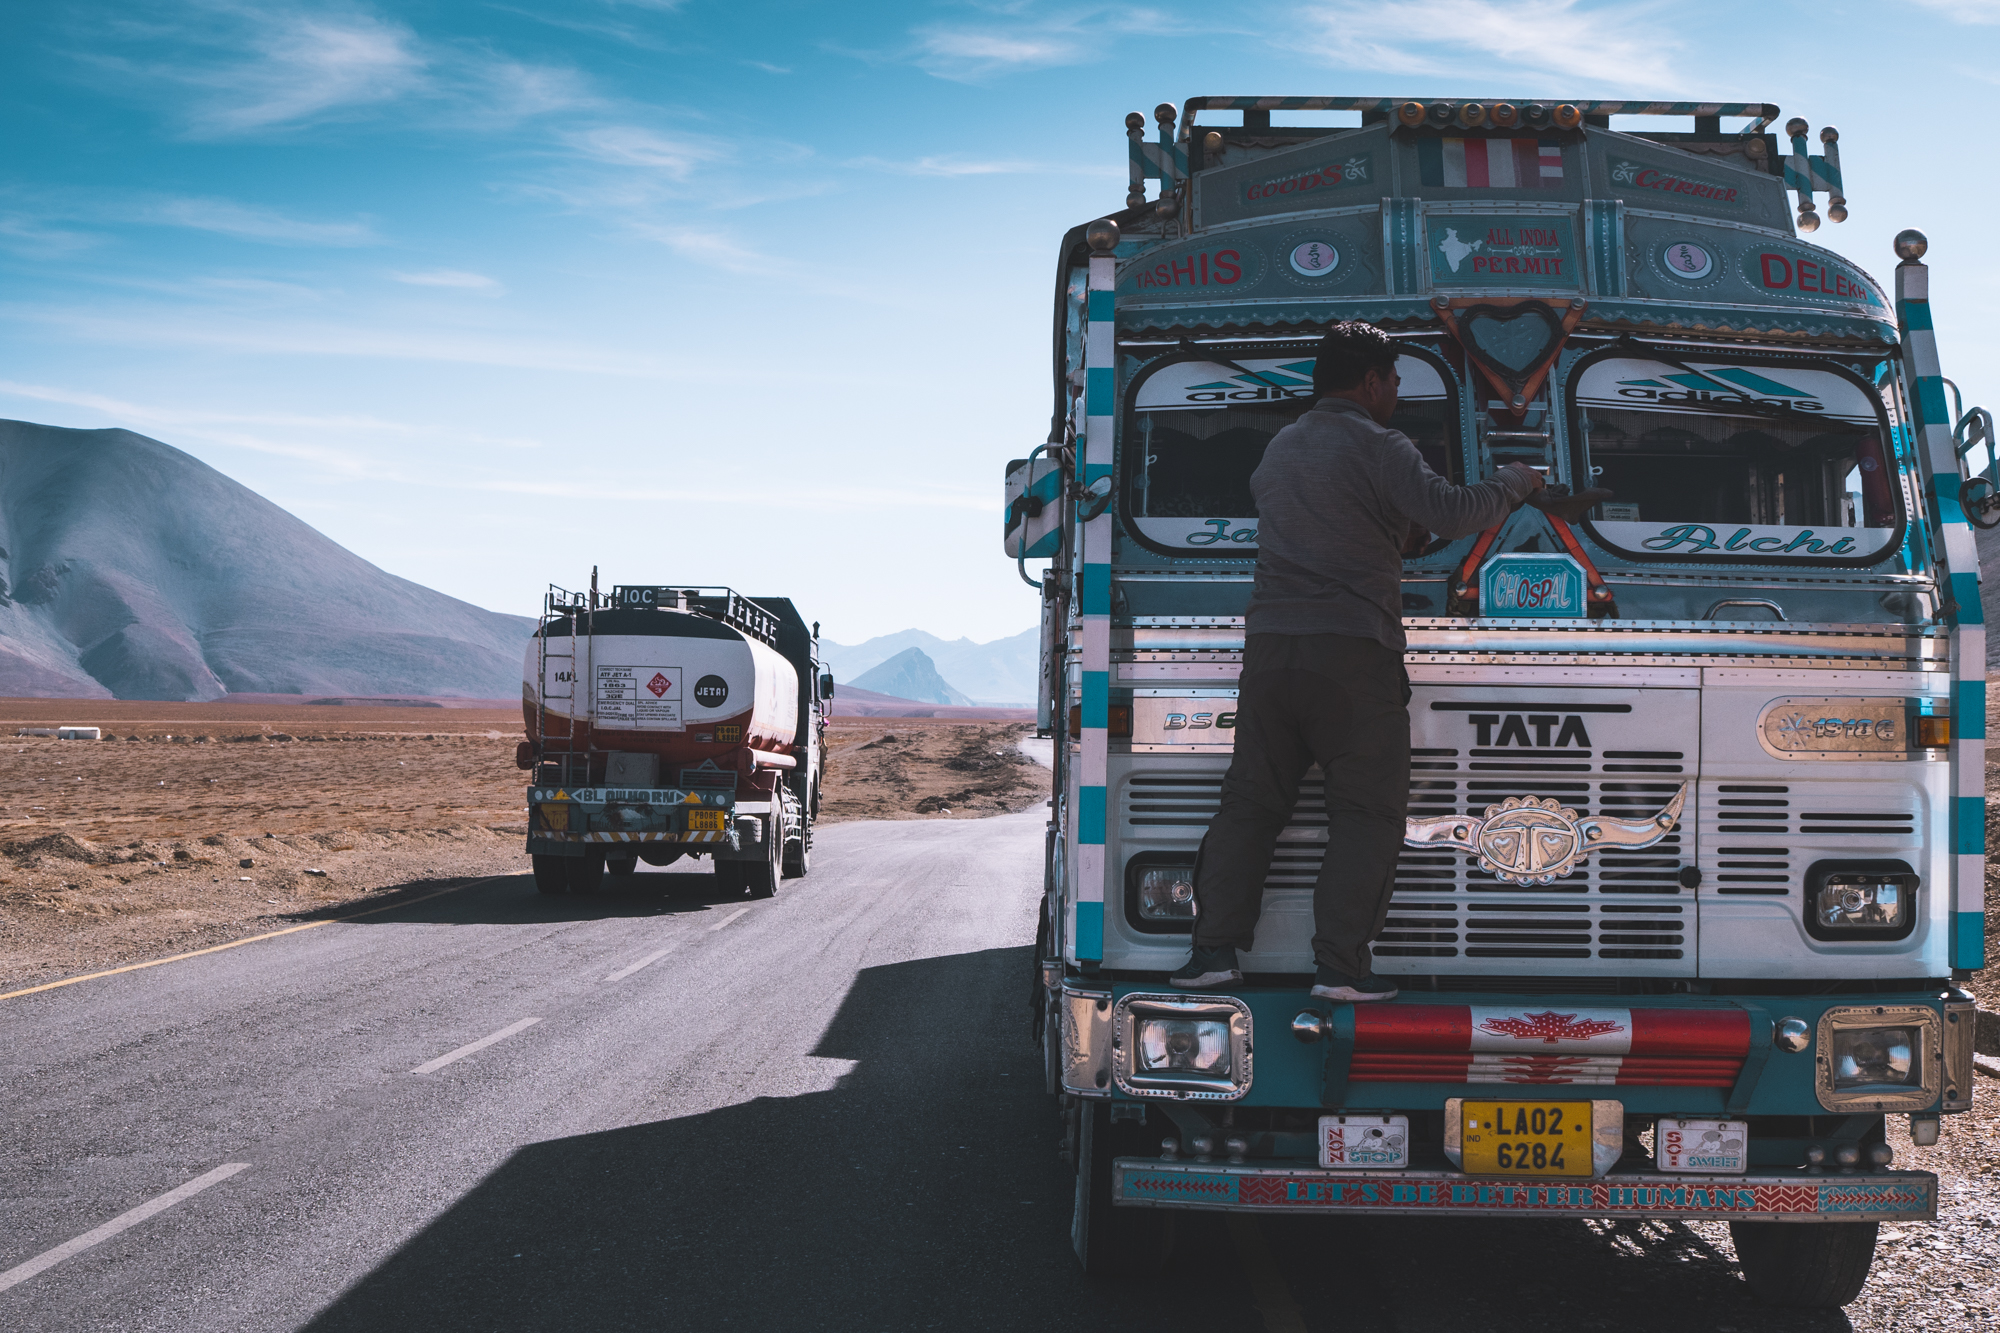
[1244,398,1530,652]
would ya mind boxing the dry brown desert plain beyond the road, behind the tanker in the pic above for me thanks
[0,699,1048,995]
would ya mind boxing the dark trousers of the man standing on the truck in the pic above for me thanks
[1194,634,1410,977]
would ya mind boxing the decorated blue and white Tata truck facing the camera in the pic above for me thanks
[1004,98,2000,1305]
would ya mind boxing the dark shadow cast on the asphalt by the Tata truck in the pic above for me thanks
[296,940,1850,1333]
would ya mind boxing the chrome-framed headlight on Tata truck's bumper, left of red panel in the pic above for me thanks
[1112,995,1250,1101]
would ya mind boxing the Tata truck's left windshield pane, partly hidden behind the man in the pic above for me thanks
[1122,354,1460,550]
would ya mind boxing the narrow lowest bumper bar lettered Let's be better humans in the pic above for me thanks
[1112,1157,1938,1223]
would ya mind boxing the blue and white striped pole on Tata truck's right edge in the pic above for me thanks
[1896,262,1986,971]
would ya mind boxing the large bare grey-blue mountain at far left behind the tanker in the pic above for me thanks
[0,420,534,699]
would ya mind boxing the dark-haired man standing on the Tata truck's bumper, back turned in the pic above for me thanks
[1172,320,1542,1001]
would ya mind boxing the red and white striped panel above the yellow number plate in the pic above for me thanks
[1348,1005,1750,1087]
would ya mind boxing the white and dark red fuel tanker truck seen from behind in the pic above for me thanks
[514,570,834,899]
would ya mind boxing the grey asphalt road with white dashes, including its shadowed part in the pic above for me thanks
[0,811,1920,1333]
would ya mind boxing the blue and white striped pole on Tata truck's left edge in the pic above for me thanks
[1070,254,1118,961]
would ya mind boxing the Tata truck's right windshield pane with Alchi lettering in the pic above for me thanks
[1570,356,1902,558]
